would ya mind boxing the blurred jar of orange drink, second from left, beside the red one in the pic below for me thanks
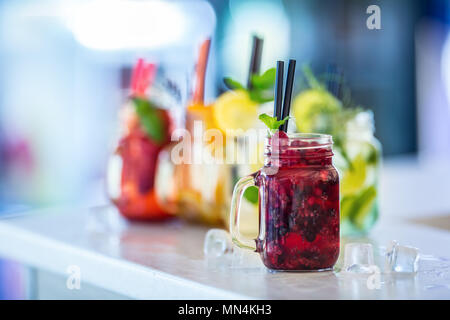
[156,106,232,226]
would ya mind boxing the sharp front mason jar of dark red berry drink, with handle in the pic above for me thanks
[230,132,339,271]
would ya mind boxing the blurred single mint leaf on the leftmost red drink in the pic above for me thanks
[133,98,166,144]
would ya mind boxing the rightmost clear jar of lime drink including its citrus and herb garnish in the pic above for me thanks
[293,70,381,235]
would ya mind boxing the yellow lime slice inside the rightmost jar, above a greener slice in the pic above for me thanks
[341,154,367,196]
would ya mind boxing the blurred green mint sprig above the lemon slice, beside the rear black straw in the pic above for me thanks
[223,68,276,104]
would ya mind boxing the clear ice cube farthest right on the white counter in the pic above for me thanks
[386,240,419,273]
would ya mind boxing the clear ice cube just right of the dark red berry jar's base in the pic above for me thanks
[343,242,374,273]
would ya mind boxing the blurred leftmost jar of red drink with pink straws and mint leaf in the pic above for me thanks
[106,60,176,220]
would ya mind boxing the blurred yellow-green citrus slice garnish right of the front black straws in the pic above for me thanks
[293,89,341,132]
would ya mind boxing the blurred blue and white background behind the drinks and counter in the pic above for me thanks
[0,0,450,297]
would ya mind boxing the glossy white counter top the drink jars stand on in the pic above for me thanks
[0,208,450,299]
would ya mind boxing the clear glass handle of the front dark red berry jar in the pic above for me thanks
[230,176,256,251]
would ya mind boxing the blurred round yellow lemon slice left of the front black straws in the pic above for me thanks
[213,90,258,135]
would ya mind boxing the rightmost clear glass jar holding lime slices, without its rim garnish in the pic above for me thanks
[335,111,381,235]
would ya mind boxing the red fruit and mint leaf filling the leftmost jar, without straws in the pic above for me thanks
[111,98,171,220]
